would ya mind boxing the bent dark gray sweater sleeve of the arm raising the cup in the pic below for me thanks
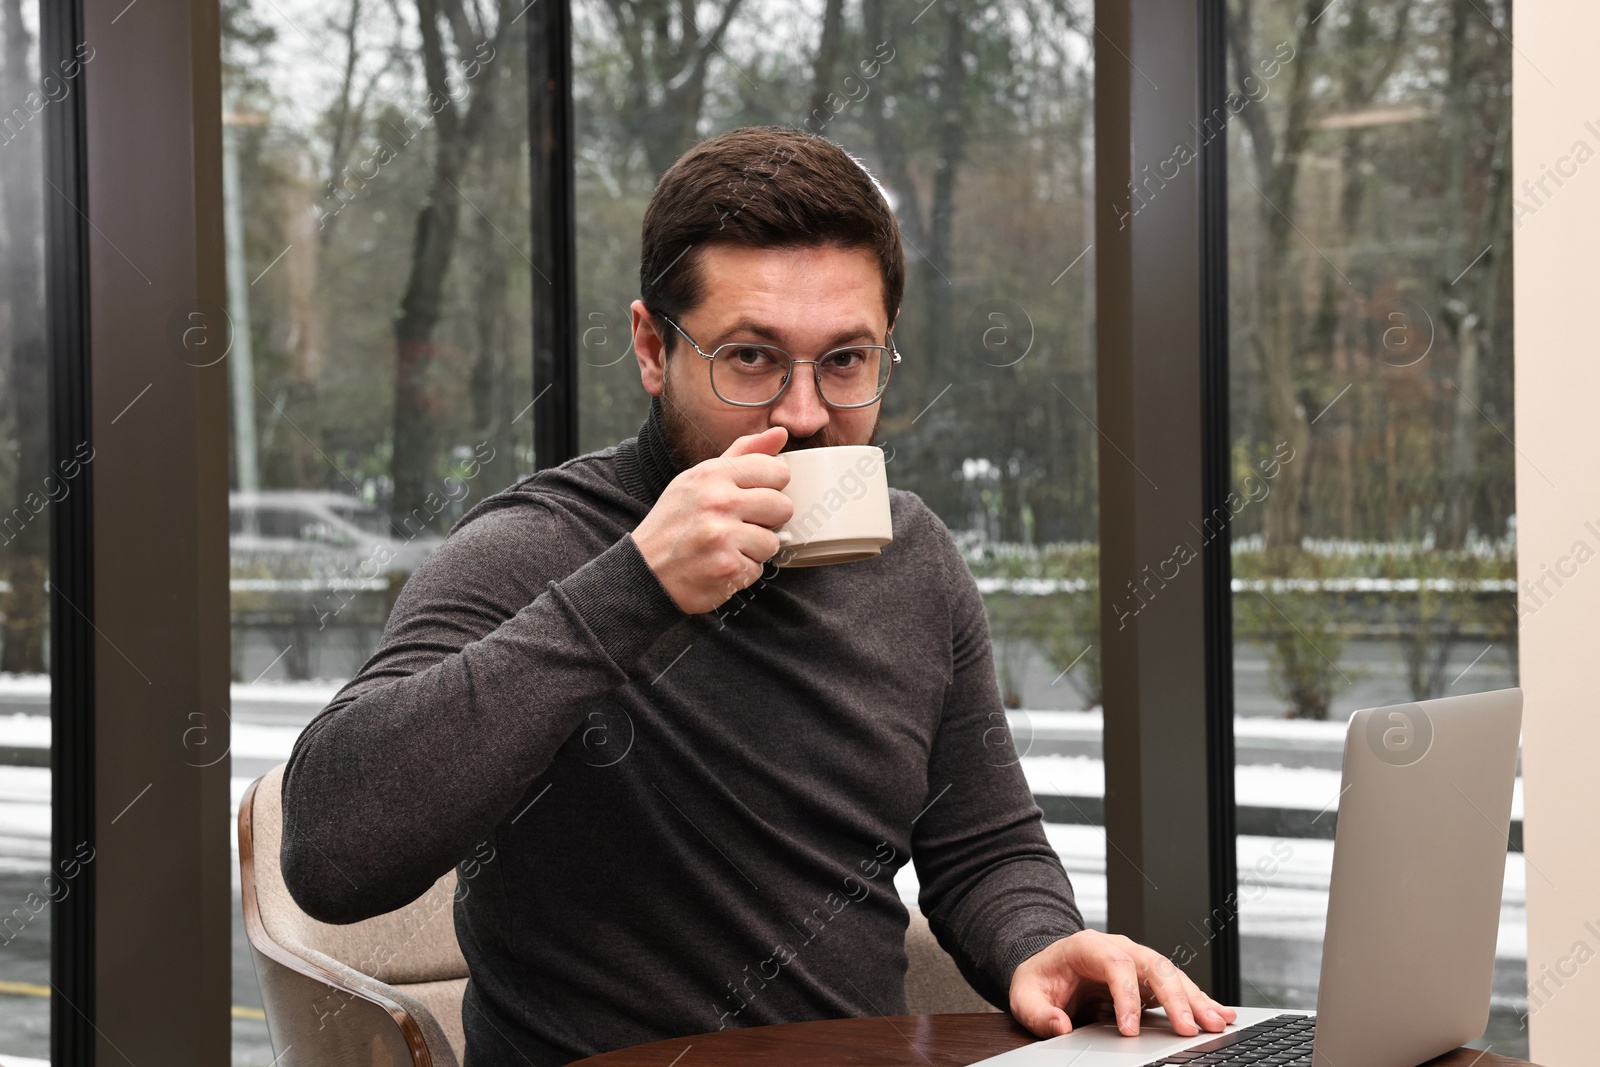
[282,507,688,923]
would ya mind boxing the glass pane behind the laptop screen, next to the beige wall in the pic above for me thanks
[1228,0,1526,1056]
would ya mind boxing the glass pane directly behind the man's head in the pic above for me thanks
[573,0,1106,925]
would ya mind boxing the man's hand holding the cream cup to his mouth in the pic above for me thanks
[634,426,795,614]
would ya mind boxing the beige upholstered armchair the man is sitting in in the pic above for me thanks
[238,766,995,1067]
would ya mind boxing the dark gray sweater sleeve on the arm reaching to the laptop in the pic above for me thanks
[912,514,1083,1011]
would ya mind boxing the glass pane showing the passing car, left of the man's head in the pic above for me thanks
[222,0,542,1065]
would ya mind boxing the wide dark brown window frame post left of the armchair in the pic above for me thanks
[38,0,234,1065]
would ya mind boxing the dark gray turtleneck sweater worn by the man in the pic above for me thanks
[282,399,1083,1067]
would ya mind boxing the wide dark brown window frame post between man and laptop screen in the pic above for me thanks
[1094,0,1240,1003]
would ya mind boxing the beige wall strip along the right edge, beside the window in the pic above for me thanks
[1512,0,1600,1067]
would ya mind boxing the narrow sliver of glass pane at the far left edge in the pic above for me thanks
[0,0,54,1062]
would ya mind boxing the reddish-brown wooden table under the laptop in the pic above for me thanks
[578,1011,1533,1067]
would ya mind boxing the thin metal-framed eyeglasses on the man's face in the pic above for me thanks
[658,314,901,408]
